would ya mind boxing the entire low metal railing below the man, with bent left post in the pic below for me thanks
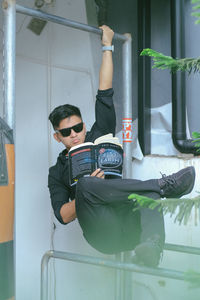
[40,244,200,300]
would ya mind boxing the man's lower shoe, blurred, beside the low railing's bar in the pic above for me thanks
[132,234,162,268]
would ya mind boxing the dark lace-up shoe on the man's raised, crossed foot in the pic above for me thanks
[158,167,195,198]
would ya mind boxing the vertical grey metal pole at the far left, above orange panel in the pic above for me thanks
[2,0,16,129]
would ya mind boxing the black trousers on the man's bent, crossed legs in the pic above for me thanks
[75,177,165,254]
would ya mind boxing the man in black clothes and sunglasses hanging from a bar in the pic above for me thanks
[48,25,195,266]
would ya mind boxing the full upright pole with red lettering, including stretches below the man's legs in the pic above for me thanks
[122,34,133,300]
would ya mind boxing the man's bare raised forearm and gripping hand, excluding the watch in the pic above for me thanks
[99,25,114,90]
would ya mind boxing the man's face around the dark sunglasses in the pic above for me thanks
[54,116,86,150]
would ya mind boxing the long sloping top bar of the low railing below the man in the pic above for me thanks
[43,251,185,280]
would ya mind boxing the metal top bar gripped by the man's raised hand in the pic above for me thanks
[16,4,128,42]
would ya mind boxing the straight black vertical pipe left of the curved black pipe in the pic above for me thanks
[138,0,151,155]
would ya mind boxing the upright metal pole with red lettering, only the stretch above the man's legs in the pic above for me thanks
[122,34,133,178]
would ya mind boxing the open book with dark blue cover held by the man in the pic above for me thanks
[69,133,123,185]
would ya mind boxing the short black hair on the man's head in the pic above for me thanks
[49,104,82,129]
